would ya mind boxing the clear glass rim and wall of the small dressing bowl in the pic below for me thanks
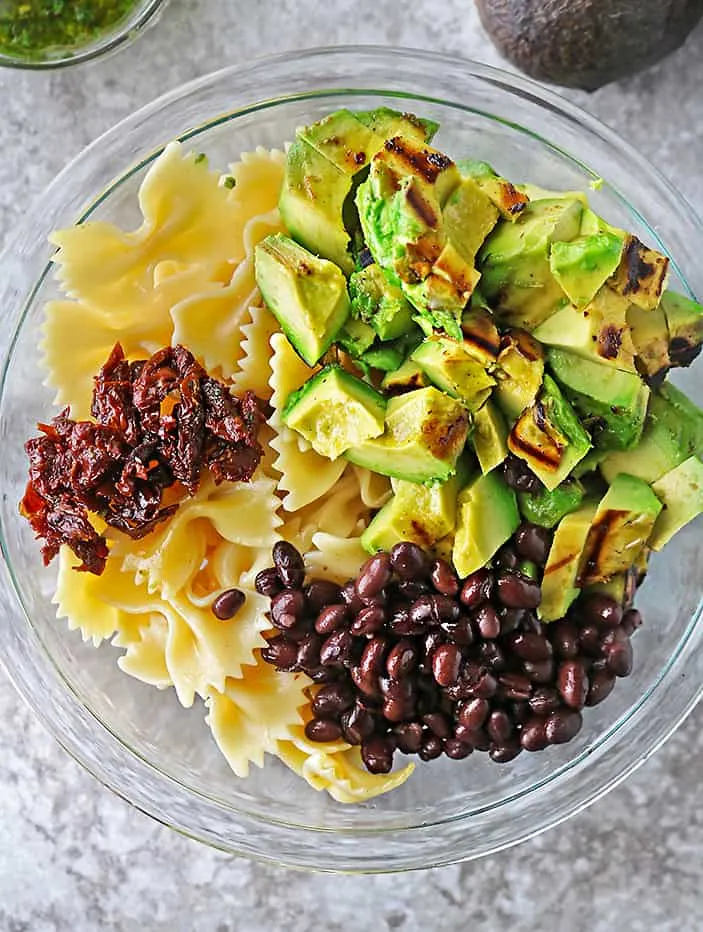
[0,0,168,71]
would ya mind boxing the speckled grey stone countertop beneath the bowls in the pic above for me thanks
[0,0,703,932]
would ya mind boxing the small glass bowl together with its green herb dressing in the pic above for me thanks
[0,0,167,69]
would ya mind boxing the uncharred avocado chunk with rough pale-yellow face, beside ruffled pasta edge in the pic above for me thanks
[282,365,386,460]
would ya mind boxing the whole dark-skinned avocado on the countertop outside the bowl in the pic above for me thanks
[476,0,703,91]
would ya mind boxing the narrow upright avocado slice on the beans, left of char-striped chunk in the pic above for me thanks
[537,502,596,621]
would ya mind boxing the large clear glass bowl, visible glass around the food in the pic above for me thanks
[0,48,703,871]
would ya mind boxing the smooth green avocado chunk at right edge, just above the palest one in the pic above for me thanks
[600,382,703,483]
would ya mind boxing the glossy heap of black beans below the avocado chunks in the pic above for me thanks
[256,524,641,773]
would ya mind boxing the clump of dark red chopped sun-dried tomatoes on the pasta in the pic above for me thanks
[20,343,263,575]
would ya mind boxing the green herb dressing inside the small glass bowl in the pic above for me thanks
[0,0,138,61]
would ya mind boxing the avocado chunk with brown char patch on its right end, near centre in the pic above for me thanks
[345,386,468,482]
